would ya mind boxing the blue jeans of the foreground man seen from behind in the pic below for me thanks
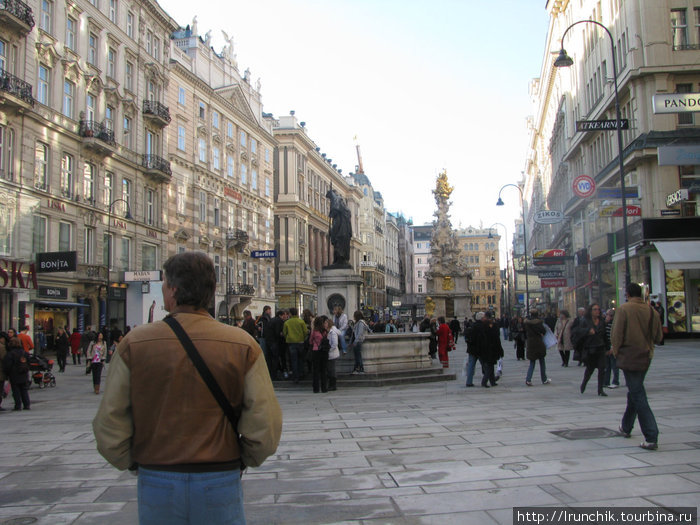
[138,468,245,525]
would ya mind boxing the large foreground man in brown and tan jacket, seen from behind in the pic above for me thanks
[93,252,282,525]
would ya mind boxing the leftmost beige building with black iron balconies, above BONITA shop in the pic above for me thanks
[0,0,178,341]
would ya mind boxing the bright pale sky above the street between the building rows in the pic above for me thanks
[160,0,548,248]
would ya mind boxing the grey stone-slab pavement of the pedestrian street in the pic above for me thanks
[0,341,700,525]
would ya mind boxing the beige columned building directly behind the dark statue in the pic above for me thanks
[271,111,360,315]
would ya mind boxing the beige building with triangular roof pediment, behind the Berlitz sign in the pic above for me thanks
[168,26,276,322]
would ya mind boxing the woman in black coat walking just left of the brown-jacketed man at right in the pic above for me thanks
[572,303,610,396]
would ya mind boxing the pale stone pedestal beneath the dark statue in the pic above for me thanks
[314,266,362,319]
